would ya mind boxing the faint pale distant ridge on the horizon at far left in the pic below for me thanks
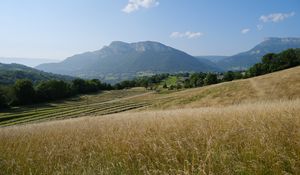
[0,57,59,67]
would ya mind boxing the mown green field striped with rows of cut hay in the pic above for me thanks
[0,88,149,127]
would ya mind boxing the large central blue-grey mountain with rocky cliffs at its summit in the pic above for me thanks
[36,41,220,81]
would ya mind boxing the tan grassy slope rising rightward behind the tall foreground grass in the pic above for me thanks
[149,66,300,108]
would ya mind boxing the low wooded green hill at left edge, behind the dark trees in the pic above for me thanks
[0,63,73,84]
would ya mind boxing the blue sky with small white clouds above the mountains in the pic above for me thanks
[0,0,300,59]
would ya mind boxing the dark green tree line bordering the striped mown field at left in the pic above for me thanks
[0,79,113,108]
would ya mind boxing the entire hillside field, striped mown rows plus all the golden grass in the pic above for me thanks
[0,67,300,174]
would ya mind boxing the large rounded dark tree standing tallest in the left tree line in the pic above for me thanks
[13,79,35,105]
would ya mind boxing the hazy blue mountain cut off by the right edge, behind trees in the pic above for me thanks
[217,38,300,70]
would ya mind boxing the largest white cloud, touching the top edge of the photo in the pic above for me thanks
[122,0,159,13]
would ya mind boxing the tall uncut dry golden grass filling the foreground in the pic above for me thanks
[0,100,300,174]
